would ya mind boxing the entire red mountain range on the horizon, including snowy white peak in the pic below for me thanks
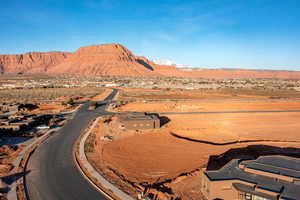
[0,44,300,79]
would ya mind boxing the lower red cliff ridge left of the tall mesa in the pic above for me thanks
[0,52,70,73]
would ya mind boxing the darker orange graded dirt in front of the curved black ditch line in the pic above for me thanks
[102,130,299,183]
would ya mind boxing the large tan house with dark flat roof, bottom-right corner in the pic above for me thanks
[201,155,300,200]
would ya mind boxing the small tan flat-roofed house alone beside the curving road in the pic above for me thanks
[118,113,160,130]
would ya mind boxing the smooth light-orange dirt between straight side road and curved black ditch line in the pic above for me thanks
[166,113,300,143]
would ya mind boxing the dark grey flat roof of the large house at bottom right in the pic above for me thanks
[205,156,300,200]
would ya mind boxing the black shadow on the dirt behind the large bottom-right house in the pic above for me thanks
[207,145,300,170]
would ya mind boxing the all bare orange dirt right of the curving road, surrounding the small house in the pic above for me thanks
[88,89,300,200]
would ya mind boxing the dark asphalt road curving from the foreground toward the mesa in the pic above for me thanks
[26,90,117,200]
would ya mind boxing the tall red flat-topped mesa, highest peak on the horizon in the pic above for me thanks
[47,44,158,77]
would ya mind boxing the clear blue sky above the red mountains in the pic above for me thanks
[0,0,300,70]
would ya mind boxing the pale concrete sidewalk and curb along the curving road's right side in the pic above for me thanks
[74,117,135,200]
